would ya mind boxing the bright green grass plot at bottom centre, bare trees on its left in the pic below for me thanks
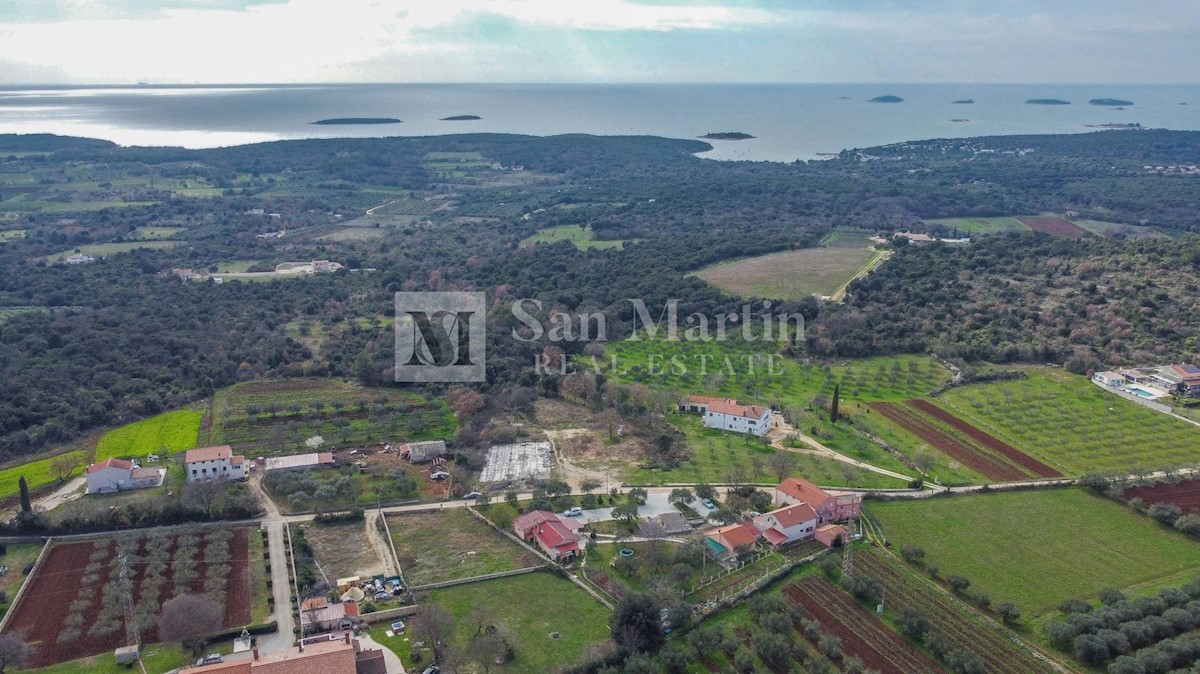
[417,573,610,673]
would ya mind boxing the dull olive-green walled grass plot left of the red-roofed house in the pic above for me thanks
[388,508,545,585]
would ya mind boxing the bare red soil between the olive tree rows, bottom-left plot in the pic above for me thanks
[6,528,253,667]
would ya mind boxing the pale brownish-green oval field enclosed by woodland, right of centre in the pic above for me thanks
[694,246,880,300]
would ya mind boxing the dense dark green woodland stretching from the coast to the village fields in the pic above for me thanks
[0,131,1200,458]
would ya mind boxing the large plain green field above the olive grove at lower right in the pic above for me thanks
[868,489,1200,615]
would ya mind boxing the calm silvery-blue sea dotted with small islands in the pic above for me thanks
[0,84,1200,161]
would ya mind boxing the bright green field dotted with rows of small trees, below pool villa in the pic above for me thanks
[938,369,1200,475]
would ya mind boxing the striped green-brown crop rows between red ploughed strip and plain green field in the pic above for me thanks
[854,549,1060,674]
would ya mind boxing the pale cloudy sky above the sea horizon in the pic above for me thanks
[0,0,1200,84]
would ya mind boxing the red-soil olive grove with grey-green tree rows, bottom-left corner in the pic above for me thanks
[7,529,253,667]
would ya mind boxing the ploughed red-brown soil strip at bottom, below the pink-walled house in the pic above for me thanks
[784,576,946,674]
